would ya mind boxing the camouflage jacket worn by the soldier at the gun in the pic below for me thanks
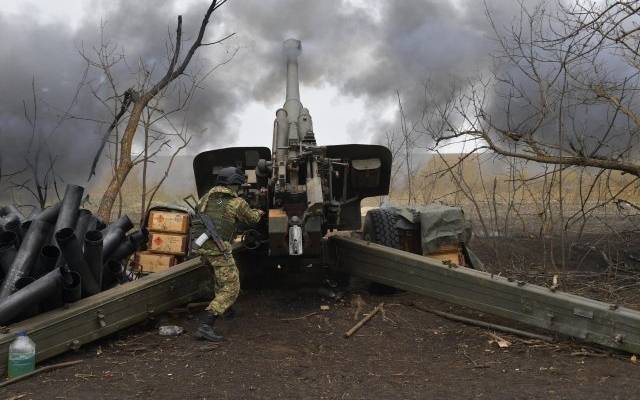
[197,186,262,256]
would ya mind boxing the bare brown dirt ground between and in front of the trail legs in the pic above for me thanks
[0,236,640,399]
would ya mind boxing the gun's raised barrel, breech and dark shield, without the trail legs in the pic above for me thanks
[193,39,392,266]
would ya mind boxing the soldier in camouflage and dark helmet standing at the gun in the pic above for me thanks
[196,167,264,342]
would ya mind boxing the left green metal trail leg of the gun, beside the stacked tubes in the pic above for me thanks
[0,258,213,376]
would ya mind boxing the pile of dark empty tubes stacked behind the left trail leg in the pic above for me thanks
[0,185,149,325]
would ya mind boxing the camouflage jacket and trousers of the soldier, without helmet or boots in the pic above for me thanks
[197,186,262,315]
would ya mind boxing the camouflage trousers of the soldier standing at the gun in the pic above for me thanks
[202,255,240,315]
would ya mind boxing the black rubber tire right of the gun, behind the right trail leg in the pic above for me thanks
[362,208,401,295]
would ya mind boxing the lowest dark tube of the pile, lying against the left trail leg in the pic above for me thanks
[0,269,62,325]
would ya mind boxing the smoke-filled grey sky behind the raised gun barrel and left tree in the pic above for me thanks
[0,0,516,194]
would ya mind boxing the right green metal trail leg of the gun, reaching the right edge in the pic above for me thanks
[330,236,640,353]
